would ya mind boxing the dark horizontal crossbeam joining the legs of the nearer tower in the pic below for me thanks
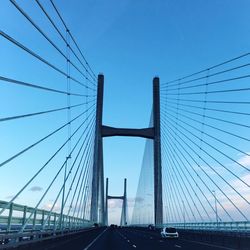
[102,126,154,139]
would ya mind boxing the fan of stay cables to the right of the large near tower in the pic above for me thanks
[161,53,250,225]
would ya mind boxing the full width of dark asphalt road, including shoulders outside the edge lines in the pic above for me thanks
[9,227,242,250]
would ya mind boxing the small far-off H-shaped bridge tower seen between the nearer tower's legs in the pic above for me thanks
[105,178,128,226]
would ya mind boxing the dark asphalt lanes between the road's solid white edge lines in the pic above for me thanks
[83,228,236,250]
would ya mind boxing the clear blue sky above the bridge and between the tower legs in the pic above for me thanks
[0,0,250,225]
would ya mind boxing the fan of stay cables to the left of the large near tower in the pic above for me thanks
[0,0,97,232]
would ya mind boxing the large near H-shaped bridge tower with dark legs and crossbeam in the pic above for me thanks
[91,74,163,225]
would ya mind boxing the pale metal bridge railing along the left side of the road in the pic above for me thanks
[0,201,93,234]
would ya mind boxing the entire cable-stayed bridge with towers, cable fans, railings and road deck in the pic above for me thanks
[0,0,250,249]
